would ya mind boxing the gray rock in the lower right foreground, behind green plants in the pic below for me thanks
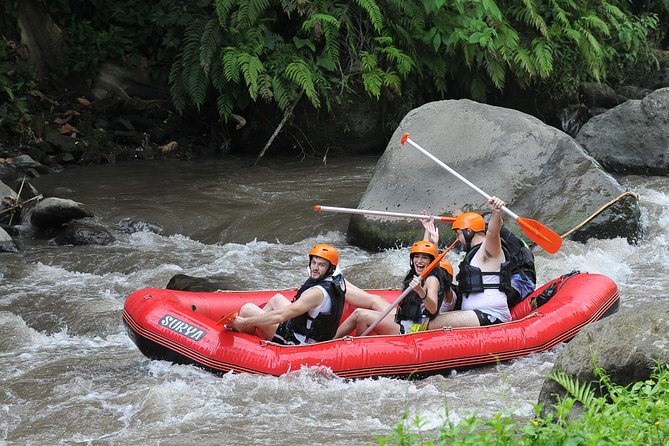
[539,301,669,410]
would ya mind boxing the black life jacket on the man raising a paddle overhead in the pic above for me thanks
[456,242,518,301]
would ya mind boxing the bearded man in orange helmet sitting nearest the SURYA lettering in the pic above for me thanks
[226,244,348,345]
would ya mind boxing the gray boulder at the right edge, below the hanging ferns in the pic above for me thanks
[576,88,669,175]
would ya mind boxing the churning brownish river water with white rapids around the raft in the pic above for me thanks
[0,157,669,446]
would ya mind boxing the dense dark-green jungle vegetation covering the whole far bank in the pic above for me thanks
[0,0,669,156]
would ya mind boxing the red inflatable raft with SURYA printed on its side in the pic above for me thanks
[123,273,620,378]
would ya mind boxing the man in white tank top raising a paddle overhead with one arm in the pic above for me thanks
[429,197,511,329]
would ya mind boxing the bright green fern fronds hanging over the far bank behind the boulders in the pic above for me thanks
[169,0,658,125]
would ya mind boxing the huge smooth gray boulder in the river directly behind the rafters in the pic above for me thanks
[347,100,641,250]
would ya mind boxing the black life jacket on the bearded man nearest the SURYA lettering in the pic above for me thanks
[285,274,346,344]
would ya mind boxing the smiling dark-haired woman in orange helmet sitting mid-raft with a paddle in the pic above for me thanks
[335,240,450,338]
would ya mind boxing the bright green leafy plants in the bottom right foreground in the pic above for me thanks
[378,364,669,446]
